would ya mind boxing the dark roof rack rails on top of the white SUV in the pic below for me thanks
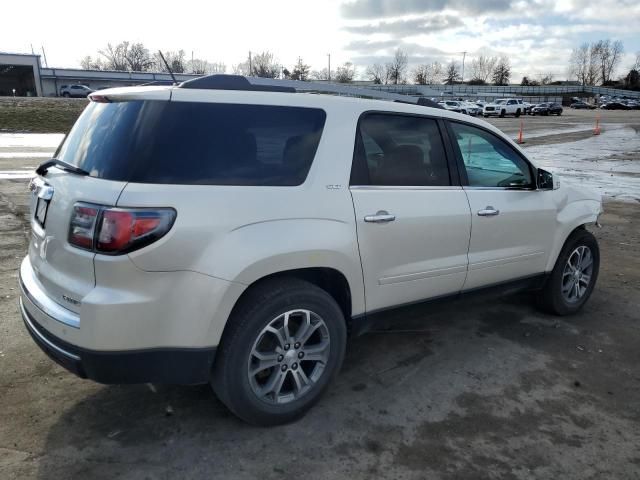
[178,74,443,108]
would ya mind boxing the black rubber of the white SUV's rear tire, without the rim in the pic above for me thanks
[211,278,347,426]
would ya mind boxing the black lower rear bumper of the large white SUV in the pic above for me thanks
[20,298,216,385]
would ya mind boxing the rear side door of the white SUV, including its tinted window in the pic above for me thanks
[350,113,471,312]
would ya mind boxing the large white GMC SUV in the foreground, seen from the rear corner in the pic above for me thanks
[20,76,601,425]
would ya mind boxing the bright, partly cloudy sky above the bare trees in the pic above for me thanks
[0,0,640,82]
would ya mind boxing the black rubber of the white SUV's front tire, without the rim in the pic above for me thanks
[537,229,600,316]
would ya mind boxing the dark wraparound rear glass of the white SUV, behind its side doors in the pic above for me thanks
[56,101,326,186]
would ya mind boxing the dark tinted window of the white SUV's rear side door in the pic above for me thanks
[351,113,450,186]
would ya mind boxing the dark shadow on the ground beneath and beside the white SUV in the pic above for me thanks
[32,294,560,479]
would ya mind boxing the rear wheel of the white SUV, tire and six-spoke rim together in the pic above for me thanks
[211,278,347,426]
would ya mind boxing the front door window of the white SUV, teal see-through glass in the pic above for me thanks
[451,122,533,188]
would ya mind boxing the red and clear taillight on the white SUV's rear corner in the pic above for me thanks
[69,204,176,255]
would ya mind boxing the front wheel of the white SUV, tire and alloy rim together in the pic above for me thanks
[538,229,600,315]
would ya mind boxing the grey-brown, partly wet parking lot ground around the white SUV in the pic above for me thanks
[0,109,640,480]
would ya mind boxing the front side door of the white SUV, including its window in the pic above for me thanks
[450,122,557,290]
